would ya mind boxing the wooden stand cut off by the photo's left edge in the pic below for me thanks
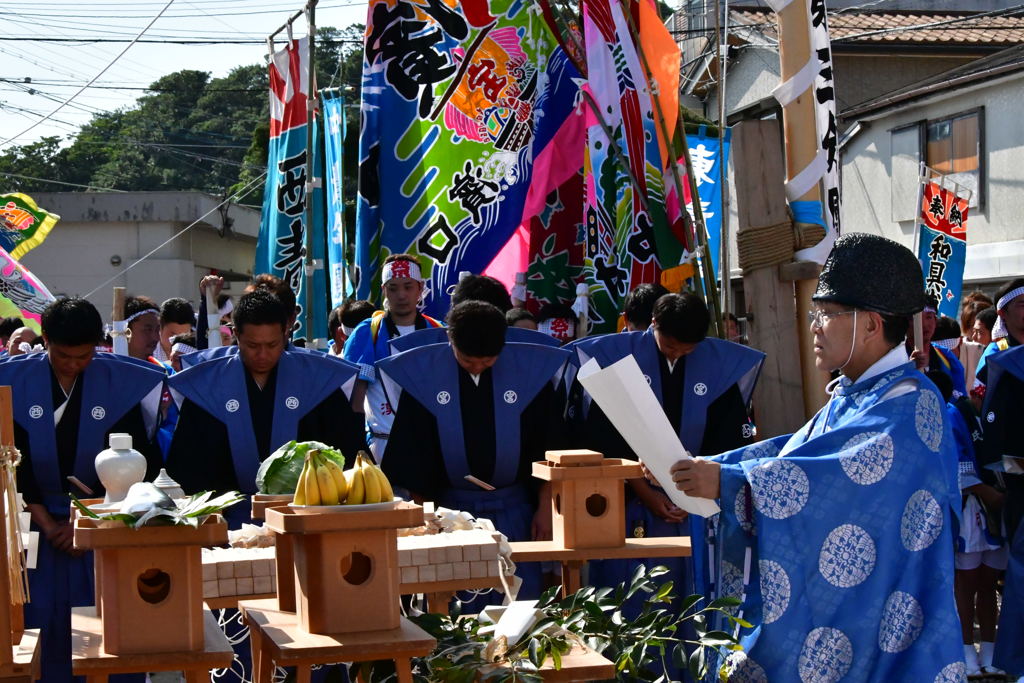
[0,386,40,683]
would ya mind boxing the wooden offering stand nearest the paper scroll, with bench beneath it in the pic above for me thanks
[509,451,691,596]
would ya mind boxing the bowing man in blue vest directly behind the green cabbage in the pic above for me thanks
[167,289,366,526]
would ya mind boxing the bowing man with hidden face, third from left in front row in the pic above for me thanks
[377,301,568,597]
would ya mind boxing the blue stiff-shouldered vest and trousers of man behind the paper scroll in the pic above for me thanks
[569,330,765,595]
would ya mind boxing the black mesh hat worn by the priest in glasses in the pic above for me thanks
[812,232,925,315]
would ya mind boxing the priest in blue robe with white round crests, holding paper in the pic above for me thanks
[673,233,965,682]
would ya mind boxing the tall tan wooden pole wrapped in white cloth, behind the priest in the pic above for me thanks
[778,0,828,420]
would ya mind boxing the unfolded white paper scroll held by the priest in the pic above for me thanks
[579,355,719,517]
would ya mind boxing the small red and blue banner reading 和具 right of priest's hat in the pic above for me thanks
[918,179,971,321]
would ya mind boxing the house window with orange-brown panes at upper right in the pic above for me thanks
[925,110,982,208]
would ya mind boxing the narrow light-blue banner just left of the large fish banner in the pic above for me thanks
[322,93,352,308]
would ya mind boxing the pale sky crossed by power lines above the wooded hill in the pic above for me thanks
[0,0,367,152]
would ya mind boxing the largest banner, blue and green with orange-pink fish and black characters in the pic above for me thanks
[353,0,579,315]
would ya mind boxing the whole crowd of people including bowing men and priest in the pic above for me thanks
[0,233,1024,681]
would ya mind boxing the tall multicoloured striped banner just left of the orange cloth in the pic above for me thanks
[583,0,683,333]
